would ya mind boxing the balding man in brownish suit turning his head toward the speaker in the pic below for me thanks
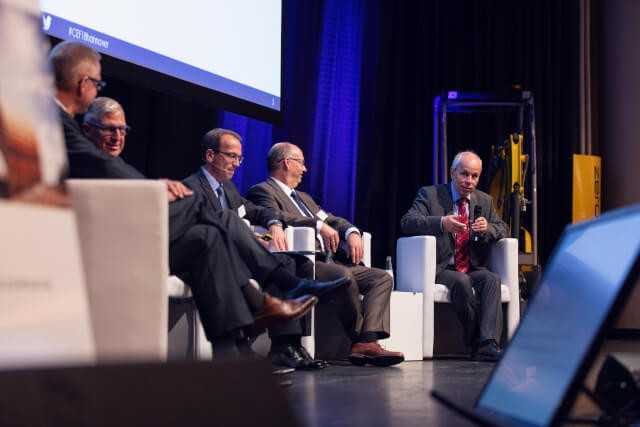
[247,142,404,366]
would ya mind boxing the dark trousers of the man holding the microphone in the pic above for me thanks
[436,269,502,346]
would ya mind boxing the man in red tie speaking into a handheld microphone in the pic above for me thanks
[401,151,509,361]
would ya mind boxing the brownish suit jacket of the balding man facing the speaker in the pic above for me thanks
[247,178,353,239]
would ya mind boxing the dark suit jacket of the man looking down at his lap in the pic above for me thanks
[183,169,284,228]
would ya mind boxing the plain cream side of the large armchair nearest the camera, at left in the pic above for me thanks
[67,180,169,361]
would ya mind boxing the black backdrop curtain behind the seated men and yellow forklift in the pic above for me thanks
[69,0,579,265]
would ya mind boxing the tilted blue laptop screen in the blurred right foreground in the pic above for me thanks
[476,206,640,426]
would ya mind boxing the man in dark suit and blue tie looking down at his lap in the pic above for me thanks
[184,128,346,369]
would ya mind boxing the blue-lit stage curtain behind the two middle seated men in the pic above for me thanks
[219,0,365,224]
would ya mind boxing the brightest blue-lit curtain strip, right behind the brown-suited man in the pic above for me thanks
[307,0,364,220]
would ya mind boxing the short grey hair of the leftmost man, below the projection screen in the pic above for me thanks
[49,41,100,90]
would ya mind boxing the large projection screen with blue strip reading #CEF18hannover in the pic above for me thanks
[40,0,282,115]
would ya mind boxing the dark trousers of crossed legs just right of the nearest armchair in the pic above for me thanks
[169,206,282,341]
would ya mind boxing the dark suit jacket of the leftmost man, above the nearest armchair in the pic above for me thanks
[58,107,145,179]
